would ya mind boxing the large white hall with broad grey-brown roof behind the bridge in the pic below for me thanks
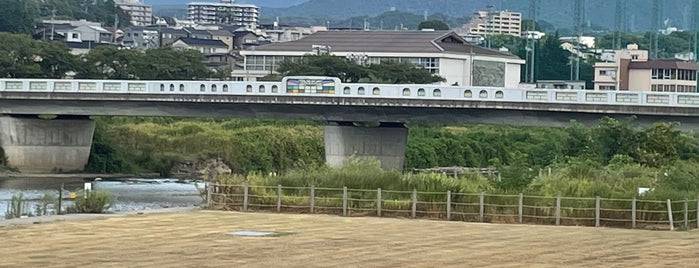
[233,31,524,87]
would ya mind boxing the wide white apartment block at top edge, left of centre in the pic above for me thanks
[187,0,260,28]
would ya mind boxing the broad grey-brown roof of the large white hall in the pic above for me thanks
[249,31,518,58]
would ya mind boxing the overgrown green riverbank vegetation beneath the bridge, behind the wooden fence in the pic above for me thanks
[83,117,699,200]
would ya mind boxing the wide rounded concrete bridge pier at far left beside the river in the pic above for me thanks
[0,116,95,173]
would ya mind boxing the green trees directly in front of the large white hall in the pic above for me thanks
[277,55,444,84]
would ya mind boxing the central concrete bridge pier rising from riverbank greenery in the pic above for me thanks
[324,122,408,170]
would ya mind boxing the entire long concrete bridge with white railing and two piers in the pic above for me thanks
[0,77,699,172]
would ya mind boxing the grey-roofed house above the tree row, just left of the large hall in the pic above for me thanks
[172,37,234,68]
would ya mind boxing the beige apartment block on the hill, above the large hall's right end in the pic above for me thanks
[463,11,522,36]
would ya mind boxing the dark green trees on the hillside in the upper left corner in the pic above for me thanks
[0,0,131,33]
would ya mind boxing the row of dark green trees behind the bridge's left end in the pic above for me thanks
[0,32,221,80]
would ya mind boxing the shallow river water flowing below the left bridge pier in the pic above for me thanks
[0,178,203,220]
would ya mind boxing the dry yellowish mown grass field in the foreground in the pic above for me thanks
[0,210,699,268]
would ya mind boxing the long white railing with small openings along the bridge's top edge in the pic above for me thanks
[0,79,699,107]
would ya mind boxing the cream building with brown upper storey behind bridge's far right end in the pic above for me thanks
[594,44,697,92]
